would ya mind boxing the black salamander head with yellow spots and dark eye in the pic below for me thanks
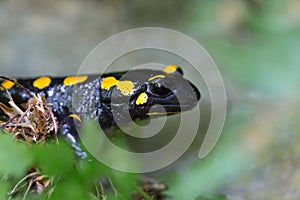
[101,65,200,123]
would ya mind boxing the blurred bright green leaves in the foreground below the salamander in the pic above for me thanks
[0,129,137,200]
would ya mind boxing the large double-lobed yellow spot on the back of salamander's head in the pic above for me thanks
[101,77,134,96]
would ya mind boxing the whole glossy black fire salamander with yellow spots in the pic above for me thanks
[0,65,200,157]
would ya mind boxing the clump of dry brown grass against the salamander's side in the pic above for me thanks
[0,85,58,143]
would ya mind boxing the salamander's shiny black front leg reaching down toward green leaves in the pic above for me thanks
[59,117,87,159]
